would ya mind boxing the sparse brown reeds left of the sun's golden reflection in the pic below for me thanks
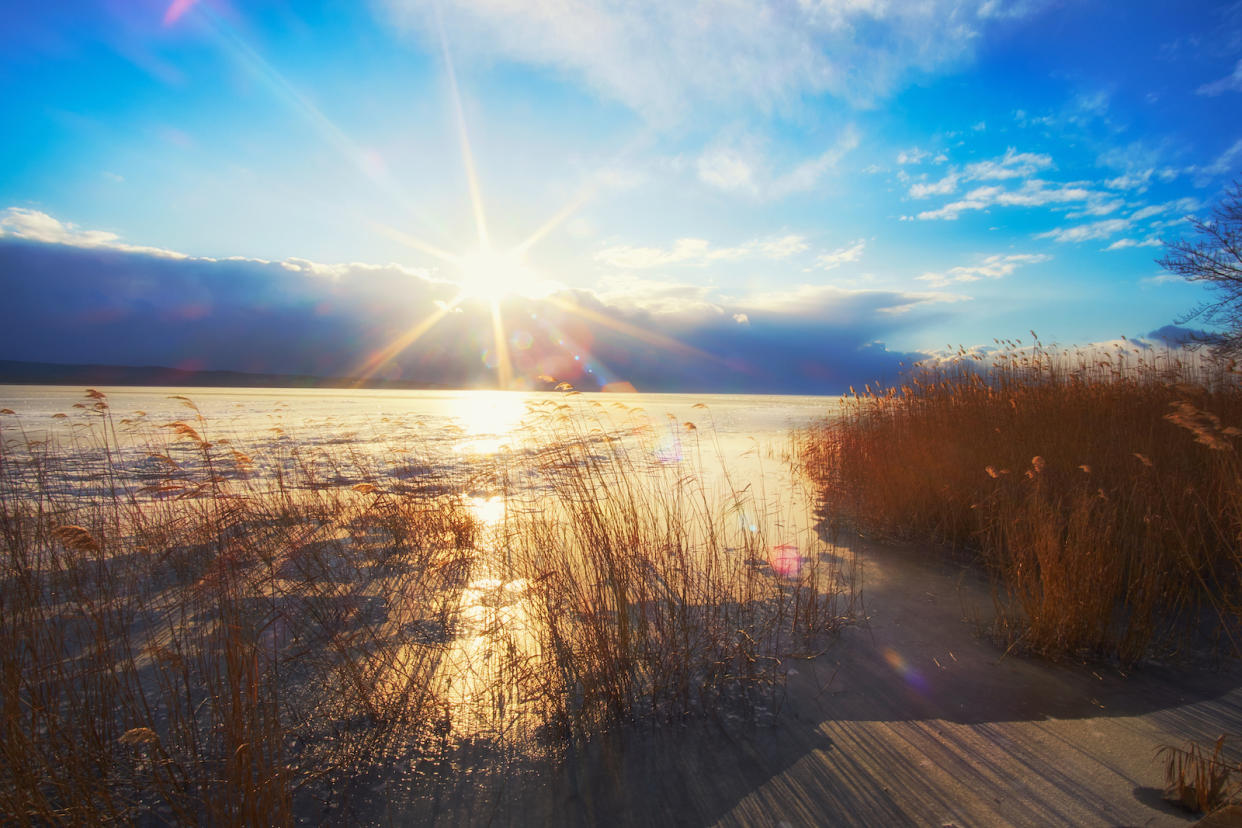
[0,392,473,824]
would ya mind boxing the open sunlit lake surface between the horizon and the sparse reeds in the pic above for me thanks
[0,385,840,546]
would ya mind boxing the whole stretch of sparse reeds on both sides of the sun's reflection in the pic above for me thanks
[0,391,848,824]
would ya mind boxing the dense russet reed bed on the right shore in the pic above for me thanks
[802,340,1242,663]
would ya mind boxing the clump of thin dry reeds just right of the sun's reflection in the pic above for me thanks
[512,403,850,736]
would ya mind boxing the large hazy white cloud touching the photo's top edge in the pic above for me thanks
[385,0,1036,118]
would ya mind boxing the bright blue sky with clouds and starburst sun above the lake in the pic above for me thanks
[0,0,1242,391]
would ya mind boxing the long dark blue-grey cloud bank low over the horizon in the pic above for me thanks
[0,210,945,394]
